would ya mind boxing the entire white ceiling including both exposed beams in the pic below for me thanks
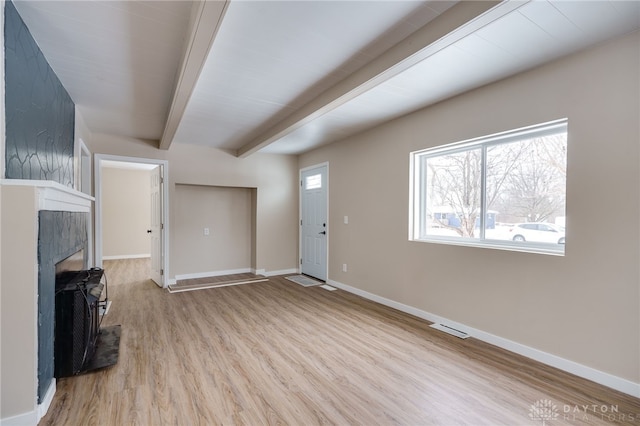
[10,0,640,155]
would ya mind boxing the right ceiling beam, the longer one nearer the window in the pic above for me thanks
[236,0,529,157]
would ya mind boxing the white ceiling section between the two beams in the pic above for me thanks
[175,0,453,149]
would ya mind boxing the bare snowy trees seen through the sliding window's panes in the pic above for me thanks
[425,132,567,238]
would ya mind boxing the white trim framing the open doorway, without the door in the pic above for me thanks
[93,154,170,287]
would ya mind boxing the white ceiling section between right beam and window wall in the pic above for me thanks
[263,1,640,153]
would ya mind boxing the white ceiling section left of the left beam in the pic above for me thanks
[14,0,191,139]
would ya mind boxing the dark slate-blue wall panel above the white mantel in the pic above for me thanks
[4,2,75,187]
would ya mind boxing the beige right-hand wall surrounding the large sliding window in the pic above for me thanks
[300,33,640,394]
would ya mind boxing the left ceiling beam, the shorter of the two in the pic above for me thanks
[159,0,230,149]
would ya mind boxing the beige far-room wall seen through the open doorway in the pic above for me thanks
[101,167,151,259]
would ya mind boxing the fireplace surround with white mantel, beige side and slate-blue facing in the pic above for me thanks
[0,179,93,424]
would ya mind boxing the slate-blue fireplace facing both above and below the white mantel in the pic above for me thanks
[4,1,79,402]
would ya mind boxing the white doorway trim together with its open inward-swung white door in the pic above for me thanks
[94,154,169,287]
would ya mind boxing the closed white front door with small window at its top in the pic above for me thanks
[300,165,328,281]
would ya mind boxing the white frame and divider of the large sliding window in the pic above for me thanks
[409,118,568,256]
